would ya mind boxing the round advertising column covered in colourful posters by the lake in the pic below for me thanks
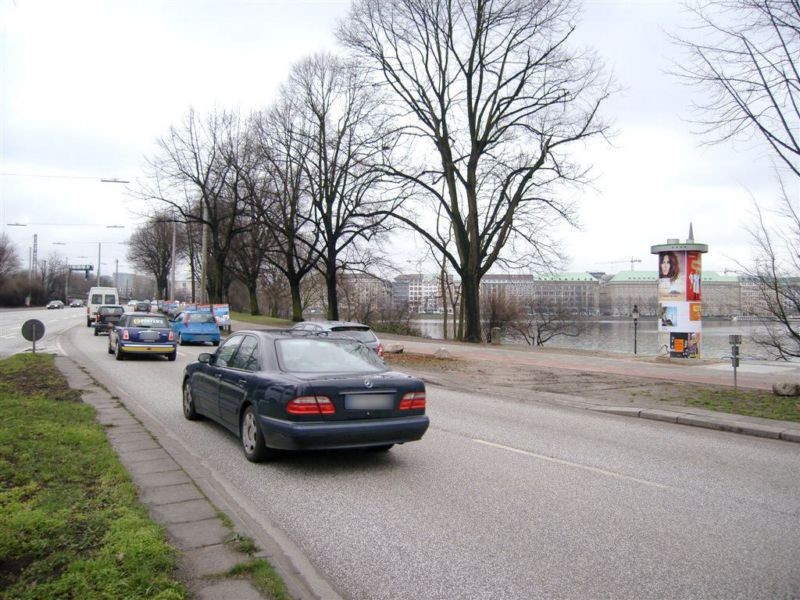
[650,234,708,358]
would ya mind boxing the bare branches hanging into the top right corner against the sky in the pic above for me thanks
[676,0,800,177]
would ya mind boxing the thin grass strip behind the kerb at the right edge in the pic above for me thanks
[686,389,800,422]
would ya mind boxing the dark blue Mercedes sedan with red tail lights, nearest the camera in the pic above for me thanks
[183,331,429,462]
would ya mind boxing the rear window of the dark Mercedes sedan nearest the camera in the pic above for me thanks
[275,338,387,373]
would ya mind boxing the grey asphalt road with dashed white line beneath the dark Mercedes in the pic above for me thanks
[12,309,800,600]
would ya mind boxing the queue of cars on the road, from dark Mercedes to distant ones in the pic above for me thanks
[87,291,429,462]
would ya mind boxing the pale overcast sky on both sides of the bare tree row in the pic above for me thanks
[0,0,788,274]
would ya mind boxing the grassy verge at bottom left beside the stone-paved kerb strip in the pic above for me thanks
[0,354,186,599]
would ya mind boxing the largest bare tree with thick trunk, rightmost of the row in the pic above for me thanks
[339,0,609,342]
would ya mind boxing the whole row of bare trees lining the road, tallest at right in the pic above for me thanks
[130,0,611,342]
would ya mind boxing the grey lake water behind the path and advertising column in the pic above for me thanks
[412,319,767,359]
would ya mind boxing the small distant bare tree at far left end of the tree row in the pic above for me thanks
[127,213,182,300]
